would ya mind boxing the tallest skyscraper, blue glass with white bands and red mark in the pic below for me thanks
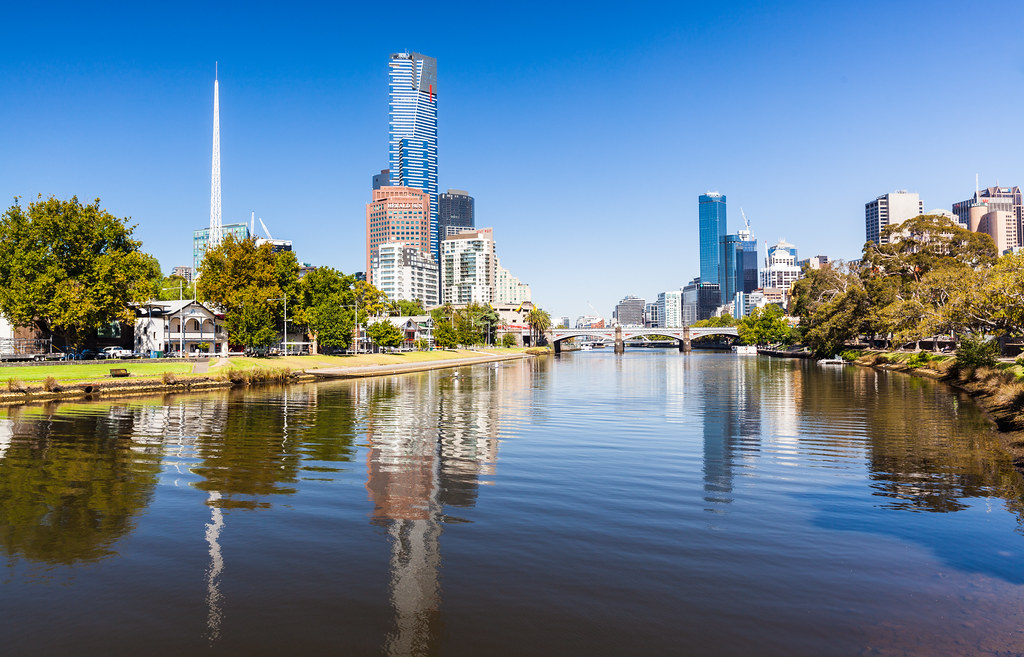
[388,52,440,260]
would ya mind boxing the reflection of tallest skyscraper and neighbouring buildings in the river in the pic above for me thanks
[359,362,531,655]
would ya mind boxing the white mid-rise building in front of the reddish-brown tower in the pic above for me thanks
[370,242,438,308]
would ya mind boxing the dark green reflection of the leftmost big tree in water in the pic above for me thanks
[0,406,160,564]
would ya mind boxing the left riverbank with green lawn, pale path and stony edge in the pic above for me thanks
[0,349,537,405]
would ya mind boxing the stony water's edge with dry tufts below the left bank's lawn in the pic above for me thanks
[0,349,538,404]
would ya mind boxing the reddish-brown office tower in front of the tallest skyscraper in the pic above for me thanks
[367,187,436,286]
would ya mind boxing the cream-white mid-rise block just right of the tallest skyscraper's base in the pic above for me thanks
[440,228,498,305]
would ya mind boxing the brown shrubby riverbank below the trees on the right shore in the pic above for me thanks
[842,345,1024,471]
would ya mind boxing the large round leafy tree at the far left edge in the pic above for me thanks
[0,196,160,348]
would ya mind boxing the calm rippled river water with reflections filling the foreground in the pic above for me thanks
[0,350,1024,656]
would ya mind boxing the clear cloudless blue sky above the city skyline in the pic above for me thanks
[0,2,1024,318]
